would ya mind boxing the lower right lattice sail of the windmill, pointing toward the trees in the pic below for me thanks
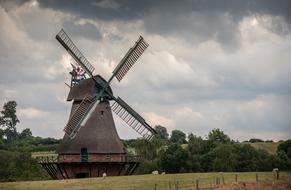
[111,97,156,140]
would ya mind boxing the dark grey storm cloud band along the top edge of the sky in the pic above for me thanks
[40,0,291,20]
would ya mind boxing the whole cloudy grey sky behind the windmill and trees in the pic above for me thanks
[0,0,291,141]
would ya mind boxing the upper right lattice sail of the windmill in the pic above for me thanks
[113,36,149,81]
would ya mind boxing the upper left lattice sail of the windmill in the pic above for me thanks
[56,29,95,77]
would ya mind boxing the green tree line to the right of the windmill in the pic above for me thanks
[125,126,291,174]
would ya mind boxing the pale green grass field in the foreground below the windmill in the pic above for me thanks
[0,172,291,190]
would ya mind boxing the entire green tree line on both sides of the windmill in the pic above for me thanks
[0,101,291,181]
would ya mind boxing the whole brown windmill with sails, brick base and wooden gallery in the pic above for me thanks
[38,29,160,179]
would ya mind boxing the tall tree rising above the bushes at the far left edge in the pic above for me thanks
[0,101,19,142]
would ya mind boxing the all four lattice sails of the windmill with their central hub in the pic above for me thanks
[56,29,156,140]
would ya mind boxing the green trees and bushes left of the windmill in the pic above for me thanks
[0,101,60,181]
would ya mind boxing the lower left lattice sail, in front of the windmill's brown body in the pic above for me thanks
[64,96,98,139]
